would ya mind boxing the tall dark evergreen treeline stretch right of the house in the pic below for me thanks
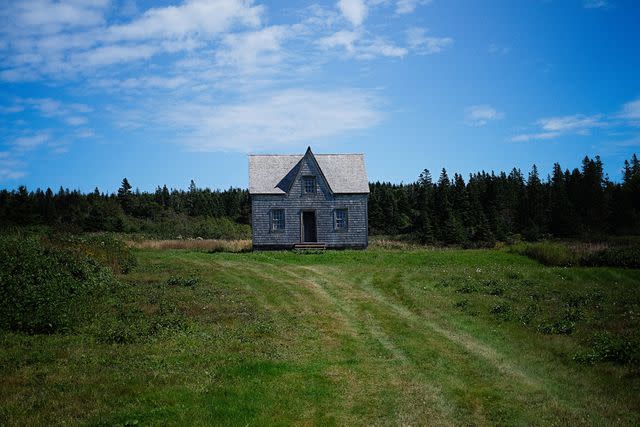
[369,154,640,244]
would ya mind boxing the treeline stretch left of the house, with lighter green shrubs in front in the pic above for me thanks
[0,178,250,238]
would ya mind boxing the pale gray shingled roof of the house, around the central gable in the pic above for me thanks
[249,148,369,194]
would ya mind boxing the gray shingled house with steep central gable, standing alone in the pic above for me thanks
[249,147,369,249]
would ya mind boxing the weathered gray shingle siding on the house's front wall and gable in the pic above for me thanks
[251,155,368,249]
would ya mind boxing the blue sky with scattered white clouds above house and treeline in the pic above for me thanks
[0,0,640,191]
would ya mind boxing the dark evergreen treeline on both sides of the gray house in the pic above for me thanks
[0,154,640,245]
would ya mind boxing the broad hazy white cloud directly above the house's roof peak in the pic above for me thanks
[160,89,382,152]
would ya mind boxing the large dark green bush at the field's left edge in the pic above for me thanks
[0,235,117,333]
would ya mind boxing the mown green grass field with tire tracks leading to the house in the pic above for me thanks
[0,248,640,426]
